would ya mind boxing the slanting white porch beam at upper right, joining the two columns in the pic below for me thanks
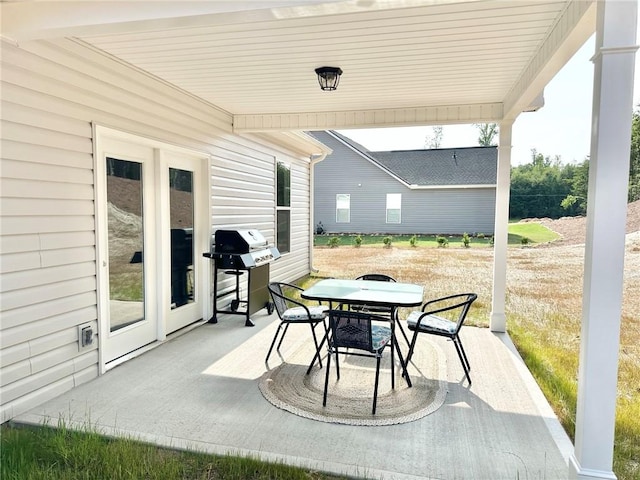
[504,0,596,120]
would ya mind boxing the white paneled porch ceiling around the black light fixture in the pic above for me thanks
[3,0,595,128]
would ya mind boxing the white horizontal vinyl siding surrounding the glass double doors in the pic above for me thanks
[0,40,310,422]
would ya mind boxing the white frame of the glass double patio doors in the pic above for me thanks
[93,125,211,374]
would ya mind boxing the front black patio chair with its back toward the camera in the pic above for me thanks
[322,310,394,415]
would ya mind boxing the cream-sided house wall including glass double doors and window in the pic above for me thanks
[0,39,327,422]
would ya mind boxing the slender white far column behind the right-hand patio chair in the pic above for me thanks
[490,122,513,332]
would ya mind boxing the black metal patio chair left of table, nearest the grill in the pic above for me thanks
[265,282,329,375]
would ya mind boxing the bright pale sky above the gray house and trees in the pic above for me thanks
[340,36,640,165]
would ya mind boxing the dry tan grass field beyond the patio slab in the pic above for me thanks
[313,215,640,479]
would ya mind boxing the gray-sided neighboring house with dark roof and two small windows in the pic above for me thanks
[312,131,498,234]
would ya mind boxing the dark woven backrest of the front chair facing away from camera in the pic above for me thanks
[329,310,373,352]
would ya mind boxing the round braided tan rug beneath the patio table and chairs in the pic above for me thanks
[259,339,447,426]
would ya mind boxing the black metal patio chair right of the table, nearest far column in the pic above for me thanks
[407,293,478,385]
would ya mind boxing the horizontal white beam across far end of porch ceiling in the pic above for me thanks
[233,103,502,133]
